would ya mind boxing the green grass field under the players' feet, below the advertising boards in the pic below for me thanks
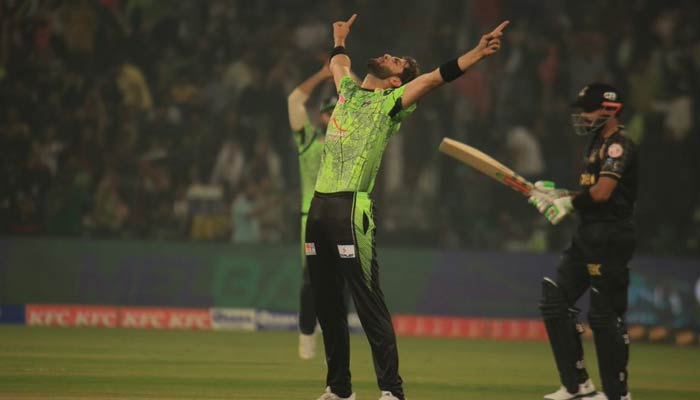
[0,326,700,400]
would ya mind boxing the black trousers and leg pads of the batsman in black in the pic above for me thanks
[540,221,635,399]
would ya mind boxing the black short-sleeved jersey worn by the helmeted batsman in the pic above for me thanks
[580,130,639,222]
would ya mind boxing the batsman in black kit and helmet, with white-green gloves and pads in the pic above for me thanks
[530,83,638,400]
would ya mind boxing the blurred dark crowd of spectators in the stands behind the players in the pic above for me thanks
[0,0,700,256]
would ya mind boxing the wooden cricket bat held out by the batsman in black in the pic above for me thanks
[439,137,533,197]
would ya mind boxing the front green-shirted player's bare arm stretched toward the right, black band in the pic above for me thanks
[400,21,510,108]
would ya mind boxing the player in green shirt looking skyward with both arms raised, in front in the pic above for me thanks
[305,15,507,400]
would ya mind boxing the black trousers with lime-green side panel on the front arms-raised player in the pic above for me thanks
[305,192,404,399]
